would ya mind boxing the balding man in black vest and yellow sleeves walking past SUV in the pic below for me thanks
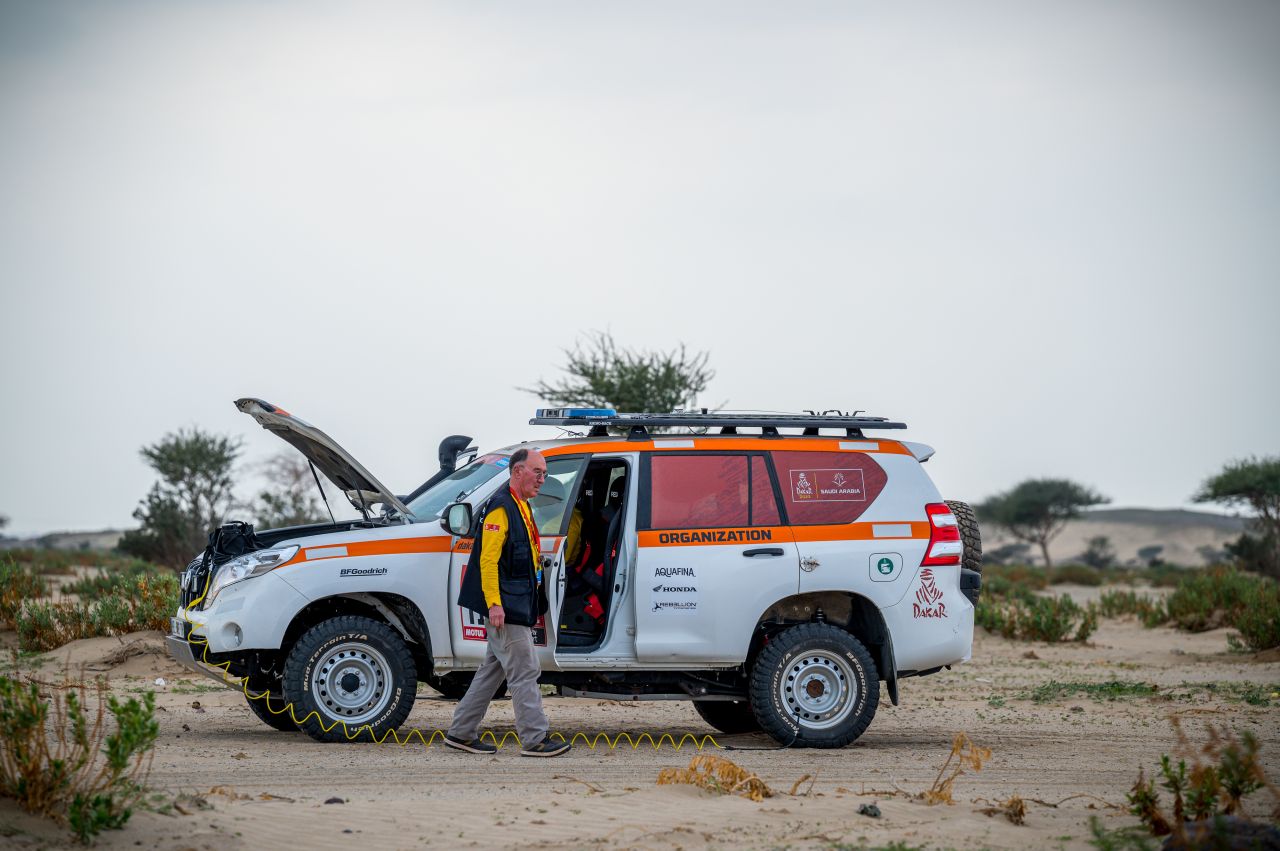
[444,449,570,756]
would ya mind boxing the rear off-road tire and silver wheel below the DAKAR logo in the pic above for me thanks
[751,623,879,747]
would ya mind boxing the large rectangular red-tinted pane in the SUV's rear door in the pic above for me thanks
[649,456,749,529]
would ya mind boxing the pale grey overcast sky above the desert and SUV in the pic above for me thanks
[0,0,1280,535]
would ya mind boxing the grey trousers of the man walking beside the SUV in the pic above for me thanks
[449,623,550,747]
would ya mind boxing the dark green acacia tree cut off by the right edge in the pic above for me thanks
[1192,456,1280,575]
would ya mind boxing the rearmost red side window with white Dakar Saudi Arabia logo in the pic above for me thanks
[773,452,888,526]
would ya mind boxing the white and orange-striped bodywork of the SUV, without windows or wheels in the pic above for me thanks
[172,414,974,672]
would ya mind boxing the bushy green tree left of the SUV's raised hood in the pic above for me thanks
[119,429,241,568]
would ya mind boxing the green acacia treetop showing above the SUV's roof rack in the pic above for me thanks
[518,331,716,412]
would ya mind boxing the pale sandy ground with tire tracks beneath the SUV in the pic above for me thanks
[0,604,1280,851]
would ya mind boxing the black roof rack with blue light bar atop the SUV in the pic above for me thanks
[529,408,906,440]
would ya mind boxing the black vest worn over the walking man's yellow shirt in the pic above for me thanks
[458,488,547,627]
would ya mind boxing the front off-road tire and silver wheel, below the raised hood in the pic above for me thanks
[284,614,417,742]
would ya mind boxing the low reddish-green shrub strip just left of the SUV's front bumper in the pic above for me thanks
[17,573,178,650]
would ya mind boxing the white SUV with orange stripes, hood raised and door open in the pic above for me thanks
[169,399,980,747]
